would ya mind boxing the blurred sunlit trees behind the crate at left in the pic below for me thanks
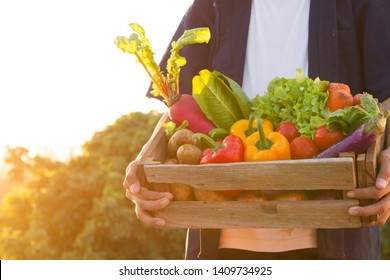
[0,111,185,260]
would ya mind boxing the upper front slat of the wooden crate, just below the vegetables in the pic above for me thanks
[144,158,356,190]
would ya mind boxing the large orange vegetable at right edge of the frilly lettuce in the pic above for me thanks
[326,83,353,112]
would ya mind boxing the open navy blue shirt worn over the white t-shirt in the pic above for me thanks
[154,0,390,259]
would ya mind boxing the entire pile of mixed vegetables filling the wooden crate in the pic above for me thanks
[115,24,390,200]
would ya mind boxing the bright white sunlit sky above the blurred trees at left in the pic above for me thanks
[0,0,192,160]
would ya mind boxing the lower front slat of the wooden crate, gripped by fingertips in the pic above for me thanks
[155,200,361,228]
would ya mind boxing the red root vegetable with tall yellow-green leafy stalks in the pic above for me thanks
[115,23,215,134]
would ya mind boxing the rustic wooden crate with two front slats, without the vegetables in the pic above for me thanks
[138,112,381,228]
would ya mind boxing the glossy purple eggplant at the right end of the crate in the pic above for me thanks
[314,111,390,158]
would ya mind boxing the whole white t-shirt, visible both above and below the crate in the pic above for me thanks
[219,0,317,252]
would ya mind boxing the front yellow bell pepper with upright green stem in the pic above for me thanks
[244,119,291,161]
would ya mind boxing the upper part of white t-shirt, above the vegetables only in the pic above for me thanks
[242,0,310,98]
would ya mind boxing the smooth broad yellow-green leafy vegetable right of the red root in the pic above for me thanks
[192,69,249,130]
